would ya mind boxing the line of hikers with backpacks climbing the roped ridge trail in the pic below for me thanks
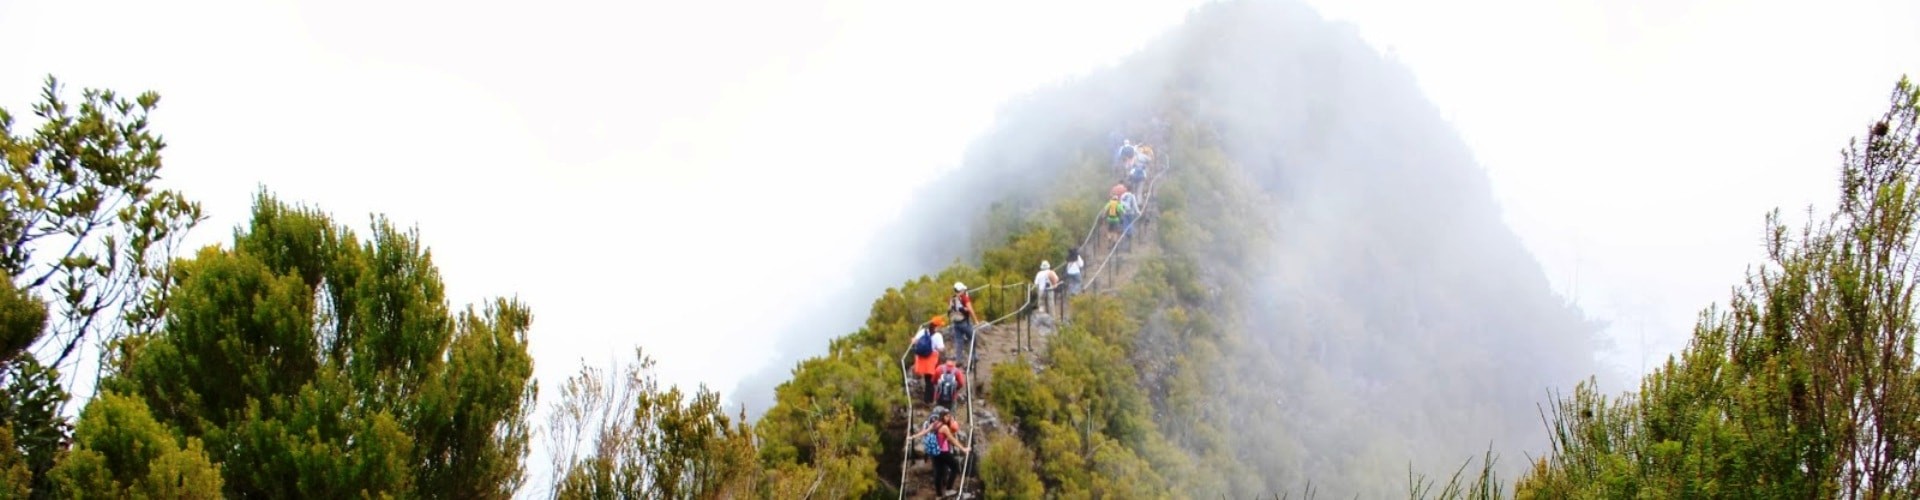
[908,131,1154,496]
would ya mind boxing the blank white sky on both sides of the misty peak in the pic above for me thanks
[0,0,1920,488]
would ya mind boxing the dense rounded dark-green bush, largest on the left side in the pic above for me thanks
[95,192,534,498]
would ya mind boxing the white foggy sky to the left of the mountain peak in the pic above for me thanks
[0,0,1188,494]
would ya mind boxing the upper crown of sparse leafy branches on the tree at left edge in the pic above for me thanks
[0,77,202,373]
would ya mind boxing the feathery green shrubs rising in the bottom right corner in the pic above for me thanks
[1517,79,1920,498]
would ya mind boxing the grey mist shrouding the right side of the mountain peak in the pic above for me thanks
[1175,2,1609,488]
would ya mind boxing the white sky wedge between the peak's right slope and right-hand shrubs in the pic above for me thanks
[1311,0,1920,386]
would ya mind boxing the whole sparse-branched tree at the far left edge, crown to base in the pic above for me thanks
[0,77,202,500]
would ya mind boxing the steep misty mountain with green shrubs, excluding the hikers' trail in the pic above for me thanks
[741,2,1594,498]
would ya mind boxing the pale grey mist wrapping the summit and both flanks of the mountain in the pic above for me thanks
[741,2,1599,496]
